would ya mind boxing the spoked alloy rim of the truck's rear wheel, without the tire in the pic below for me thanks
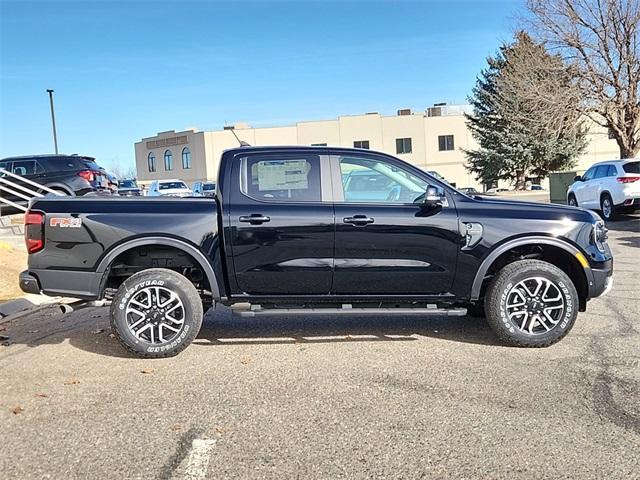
[125,287,185,344]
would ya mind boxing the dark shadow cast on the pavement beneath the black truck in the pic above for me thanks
[0,307,502,363]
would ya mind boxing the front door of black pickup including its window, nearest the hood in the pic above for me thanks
[331,152,460,295]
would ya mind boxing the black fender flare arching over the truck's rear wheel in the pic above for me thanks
[96,236,220,300]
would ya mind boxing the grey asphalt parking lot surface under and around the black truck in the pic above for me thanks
[0,216,640,479]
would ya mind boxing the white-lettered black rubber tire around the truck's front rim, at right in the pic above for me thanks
[485,260,579,348]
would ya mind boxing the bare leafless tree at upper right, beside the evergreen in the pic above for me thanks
[527,0,640,158]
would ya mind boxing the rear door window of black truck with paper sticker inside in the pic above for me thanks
[242,154,321,202]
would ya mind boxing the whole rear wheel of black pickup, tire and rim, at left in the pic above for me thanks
[111,268,203,358]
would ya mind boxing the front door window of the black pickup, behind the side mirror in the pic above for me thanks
[339,156,428,204]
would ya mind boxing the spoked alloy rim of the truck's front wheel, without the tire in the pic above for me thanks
[506,277,566,335]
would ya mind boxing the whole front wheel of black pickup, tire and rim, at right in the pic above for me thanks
[485,260,579,347]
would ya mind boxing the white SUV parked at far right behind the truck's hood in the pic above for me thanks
[567,160,640,220]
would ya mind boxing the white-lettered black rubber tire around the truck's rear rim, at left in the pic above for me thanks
[111,268,203,358]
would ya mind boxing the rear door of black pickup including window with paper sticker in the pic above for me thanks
[228,150,334,295]
